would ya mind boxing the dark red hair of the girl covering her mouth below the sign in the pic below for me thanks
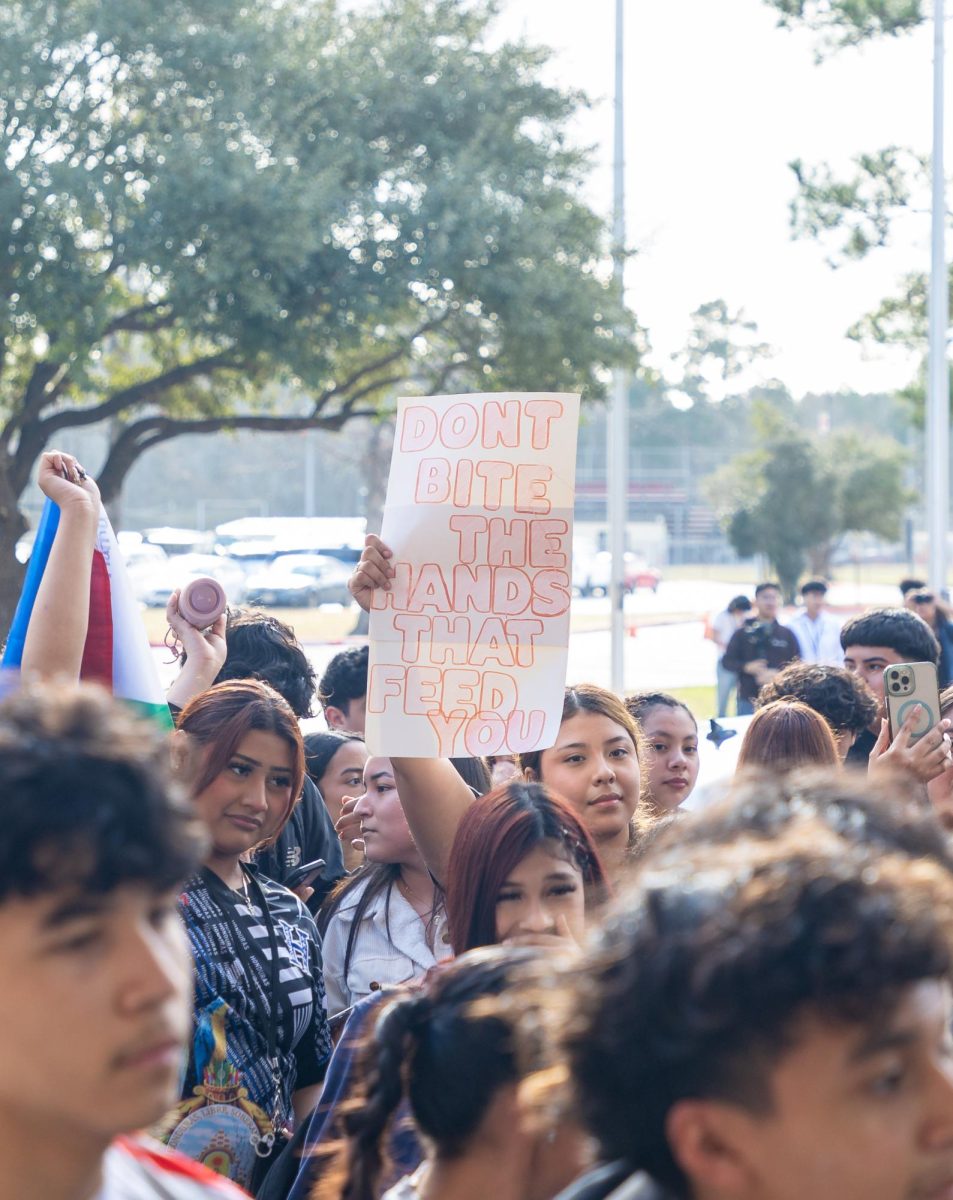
[446,780,607,954]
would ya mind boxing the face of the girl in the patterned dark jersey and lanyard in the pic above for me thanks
[194,730,294,858]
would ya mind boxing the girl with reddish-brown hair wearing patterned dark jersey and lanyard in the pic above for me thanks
[156,680,330,1192]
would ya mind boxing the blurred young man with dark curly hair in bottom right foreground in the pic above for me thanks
[553,779,953,1200]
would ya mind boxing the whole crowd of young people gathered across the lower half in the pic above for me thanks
[9,451,953,1200]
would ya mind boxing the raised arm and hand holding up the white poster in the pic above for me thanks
[348,534,473,886]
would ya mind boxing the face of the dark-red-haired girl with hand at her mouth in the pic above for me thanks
[497,842,586,946]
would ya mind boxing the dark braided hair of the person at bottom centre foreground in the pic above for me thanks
[332,947,534,1200]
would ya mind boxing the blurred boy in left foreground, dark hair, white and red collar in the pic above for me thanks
[0,685,241,1200]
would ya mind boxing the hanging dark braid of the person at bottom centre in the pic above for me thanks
[331,994,431,1200]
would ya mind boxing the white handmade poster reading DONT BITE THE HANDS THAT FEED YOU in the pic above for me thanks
[366,392,579,758]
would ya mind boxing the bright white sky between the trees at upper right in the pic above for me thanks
[498,0,951,395]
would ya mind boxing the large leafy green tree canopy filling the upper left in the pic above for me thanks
[0,0,635,607]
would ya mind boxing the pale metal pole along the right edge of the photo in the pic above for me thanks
[925,0,949,593]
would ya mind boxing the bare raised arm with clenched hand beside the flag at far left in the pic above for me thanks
[20,450,100,679]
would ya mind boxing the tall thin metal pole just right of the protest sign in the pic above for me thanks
[606,0,629,695]
